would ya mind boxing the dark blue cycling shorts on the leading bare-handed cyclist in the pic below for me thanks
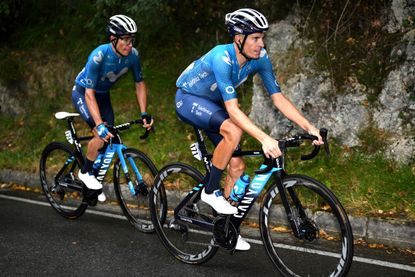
[176,89,229,146]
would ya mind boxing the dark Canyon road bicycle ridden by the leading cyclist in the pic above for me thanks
[150,128,353,276]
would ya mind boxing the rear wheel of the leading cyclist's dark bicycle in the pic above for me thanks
[150,163,217,264]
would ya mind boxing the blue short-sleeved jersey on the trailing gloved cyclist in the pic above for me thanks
[75,43,143,93]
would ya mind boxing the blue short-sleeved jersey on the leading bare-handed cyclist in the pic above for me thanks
[176,43,281,103]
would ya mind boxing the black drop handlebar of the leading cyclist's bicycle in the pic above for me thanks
[255,128,330,174]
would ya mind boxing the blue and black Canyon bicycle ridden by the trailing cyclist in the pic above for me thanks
[39,112,157,232]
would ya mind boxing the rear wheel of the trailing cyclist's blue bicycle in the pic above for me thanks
[39,142,88,219]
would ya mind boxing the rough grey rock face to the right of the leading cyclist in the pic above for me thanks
[250,5,415,163]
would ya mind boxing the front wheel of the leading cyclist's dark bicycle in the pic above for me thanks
[260,175,353,276]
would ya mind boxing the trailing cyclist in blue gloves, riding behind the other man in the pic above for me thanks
[72,15,153,201]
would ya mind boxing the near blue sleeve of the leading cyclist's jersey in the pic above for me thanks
[212,51,238,102]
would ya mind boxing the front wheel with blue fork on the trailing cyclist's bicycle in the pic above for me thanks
[114,148,157,233]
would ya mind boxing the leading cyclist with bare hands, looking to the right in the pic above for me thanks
[176,8,323,250]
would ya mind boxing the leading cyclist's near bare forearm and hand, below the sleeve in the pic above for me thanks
[225,98,281,158]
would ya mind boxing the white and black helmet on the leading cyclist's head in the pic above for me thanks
[225,9,269,36]
